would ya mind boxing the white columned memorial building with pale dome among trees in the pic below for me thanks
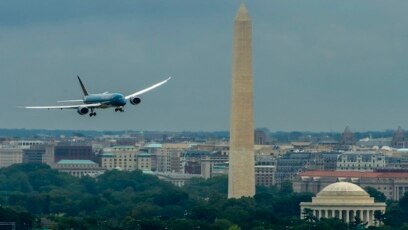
[300,182,385,226]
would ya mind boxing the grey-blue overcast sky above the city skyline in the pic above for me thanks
[0,0,408,131]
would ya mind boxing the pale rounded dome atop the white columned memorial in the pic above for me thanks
[313,182,374,204]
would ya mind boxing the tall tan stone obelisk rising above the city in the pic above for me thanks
[228,3,255,198]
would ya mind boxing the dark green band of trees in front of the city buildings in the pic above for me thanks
[0,164,408,230]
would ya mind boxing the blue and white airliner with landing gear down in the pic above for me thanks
[24,76,171,117]
